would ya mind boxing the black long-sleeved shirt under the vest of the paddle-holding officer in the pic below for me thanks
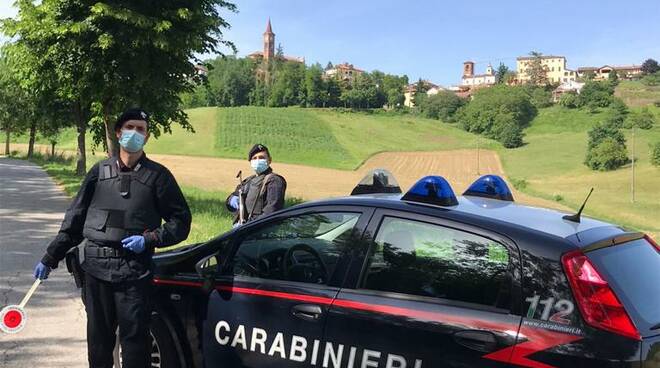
[42,154,192,281]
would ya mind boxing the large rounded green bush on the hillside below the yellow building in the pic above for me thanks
[456,85,537,148]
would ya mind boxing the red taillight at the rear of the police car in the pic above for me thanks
[561,251,641,340]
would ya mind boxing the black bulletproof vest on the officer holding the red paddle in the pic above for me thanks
[83,157,161,245]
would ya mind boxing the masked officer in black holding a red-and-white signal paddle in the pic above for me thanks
[35,109,191,368]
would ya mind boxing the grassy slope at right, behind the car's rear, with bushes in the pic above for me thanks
[499,107,660,234]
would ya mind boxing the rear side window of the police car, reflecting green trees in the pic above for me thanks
[362,217,510,306]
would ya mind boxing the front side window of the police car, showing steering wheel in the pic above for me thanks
[232,212,360,284]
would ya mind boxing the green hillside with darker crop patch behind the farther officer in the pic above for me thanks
[29,107,497,170]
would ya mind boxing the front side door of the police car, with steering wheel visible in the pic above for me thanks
[203,206,373,367]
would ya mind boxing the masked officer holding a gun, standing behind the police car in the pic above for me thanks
[226,144,286,226]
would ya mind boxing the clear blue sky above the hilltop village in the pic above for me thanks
[0,0,660,85]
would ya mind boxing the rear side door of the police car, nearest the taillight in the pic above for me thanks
[321,210,521,368]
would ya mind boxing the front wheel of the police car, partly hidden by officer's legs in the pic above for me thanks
[113,313,183,368]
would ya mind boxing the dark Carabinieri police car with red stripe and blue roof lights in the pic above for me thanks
[144,172,660,368]
